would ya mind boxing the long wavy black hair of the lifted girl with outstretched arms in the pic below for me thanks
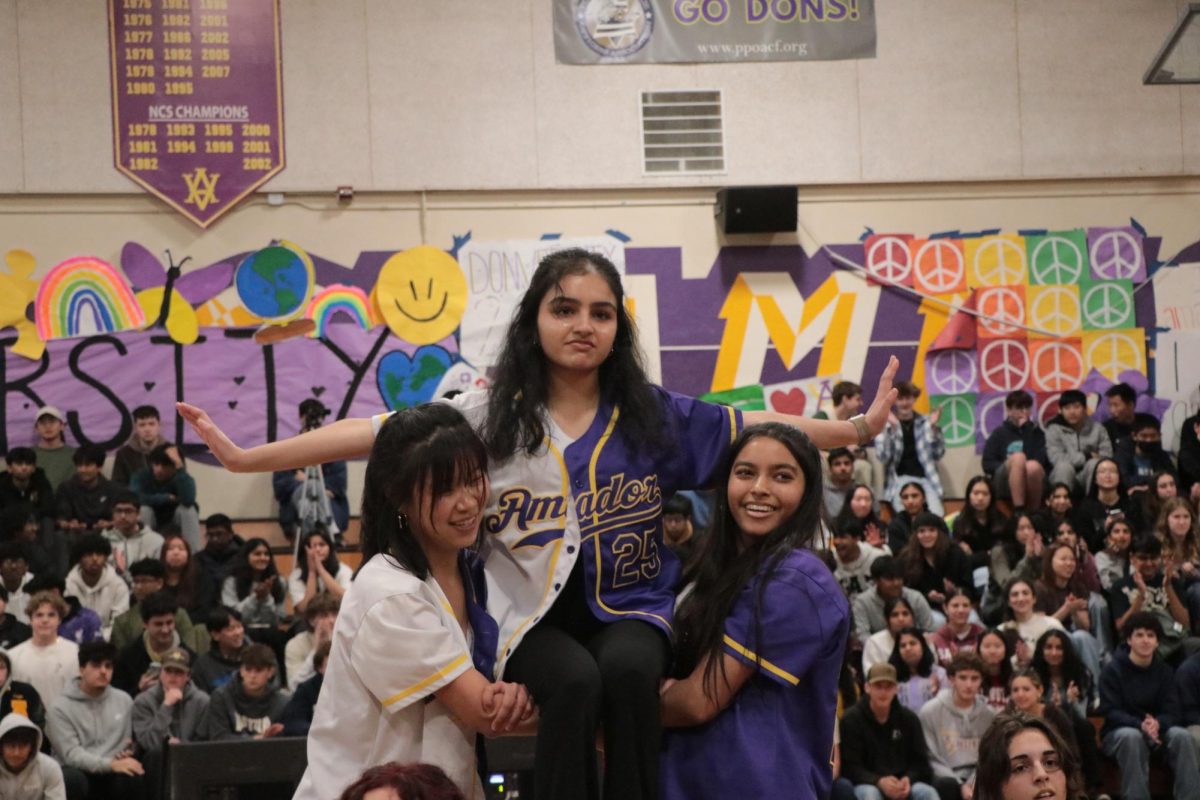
[480,248,668,461]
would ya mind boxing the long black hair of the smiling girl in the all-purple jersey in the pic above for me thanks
[674,422,823,699]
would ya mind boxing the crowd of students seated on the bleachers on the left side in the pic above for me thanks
[0,419,350,800]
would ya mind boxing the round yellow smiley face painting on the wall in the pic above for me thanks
[373,245,467,344]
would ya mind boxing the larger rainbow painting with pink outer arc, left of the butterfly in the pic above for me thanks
[34,255,145,342]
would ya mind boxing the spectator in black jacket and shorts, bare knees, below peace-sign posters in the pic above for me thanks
[983,390,1050,510]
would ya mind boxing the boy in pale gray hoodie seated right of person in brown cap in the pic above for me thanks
[920,650,996,800]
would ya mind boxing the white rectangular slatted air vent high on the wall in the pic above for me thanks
[642,89,725,175]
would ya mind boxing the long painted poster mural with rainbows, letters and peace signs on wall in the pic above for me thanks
[0,223,1180,449]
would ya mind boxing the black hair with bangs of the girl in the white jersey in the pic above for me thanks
[359,403,487,581]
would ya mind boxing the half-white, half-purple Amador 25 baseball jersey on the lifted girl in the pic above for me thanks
[376,389,742,676]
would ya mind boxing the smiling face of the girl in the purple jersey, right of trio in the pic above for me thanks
[726,437,805,540]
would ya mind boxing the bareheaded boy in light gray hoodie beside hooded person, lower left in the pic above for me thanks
[46,642,146,800]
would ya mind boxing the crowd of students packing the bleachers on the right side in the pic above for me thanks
[811,384,1200,800]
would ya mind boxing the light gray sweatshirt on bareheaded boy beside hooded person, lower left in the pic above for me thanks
[46,678,133,774]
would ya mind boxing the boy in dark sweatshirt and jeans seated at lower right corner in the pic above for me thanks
[1100,612,1200,800]
